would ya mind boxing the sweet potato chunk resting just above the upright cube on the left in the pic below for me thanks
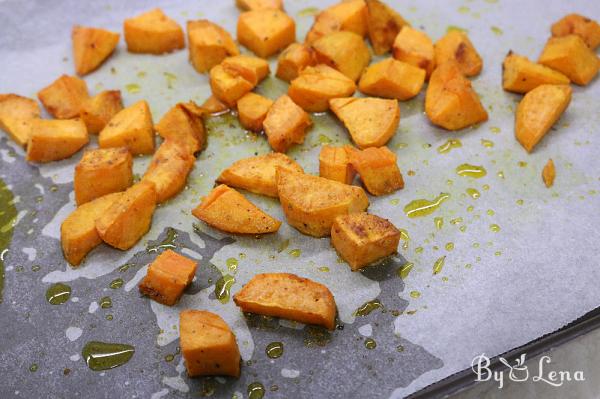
[98,100,154,155]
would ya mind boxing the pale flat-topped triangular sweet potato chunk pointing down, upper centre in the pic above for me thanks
[329,97,400,148]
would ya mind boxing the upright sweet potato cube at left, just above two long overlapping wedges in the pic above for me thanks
[73,147,133,205]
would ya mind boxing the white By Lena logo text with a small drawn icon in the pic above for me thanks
[471,353,585,389]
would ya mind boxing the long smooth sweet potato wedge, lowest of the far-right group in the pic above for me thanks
[515,85,572,152]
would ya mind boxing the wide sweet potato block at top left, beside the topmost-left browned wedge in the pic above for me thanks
[123,8,185,54]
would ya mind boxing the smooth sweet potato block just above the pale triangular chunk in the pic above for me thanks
[358,58,426,101]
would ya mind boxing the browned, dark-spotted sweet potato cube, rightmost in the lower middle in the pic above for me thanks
[331,212,400,271]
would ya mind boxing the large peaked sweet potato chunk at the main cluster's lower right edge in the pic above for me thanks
[425,61,488,130]
